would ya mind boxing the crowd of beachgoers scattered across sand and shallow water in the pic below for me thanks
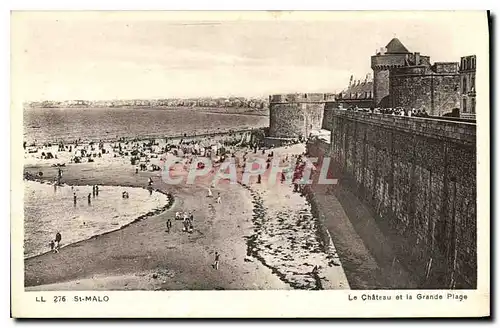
[24,131,314,269]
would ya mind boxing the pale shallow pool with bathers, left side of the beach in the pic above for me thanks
[24,181,168,258]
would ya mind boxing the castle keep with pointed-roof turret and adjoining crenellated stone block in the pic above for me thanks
[371,38,464,116]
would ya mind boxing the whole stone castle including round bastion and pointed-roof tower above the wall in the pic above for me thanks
[268,38,476,140]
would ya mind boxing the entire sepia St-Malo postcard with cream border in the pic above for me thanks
[11,11,490,316]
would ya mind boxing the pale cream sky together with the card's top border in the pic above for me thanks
[11,12,487,101]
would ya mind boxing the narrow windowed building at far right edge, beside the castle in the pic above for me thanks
[458,56,476,119]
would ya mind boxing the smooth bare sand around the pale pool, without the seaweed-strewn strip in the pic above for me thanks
[25,164,290,290]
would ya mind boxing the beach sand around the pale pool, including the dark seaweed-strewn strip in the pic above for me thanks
[25,136,349,290]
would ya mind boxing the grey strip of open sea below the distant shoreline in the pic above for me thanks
[23,108,269,144]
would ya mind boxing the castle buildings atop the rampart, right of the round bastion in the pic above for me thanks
[327,38,476,119]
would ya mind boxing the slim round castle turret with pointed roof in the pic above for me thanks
[371,38,410,107]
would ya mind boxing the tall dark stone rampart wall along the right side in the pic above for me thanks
[325,110,477,288]
